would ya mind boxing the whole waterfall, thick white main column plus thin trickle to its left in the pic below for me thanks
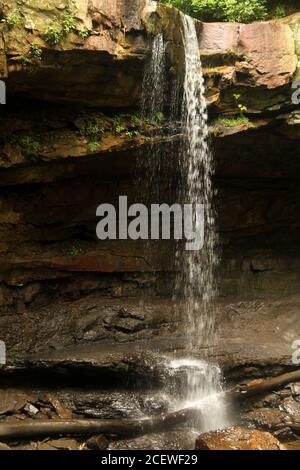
[143,3,227,431]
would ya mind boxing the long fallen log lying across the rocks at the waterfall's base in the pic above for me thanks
[0,370,300,441]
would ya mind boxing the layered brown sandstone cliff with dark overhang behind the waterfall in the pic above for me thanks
[0,0,300,382]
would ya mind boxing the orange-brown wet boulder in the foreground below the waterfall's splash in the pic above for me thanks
[196,427,285,450]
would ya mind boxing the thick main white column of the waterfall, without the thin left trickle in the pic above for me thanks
[171,14,230,430]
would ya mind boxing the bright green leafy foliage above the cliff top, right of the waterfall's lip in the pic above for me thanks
[161,0,285,23]
